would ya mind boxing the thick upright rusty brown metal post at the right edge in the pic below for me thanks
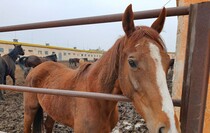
[181,2,210,133]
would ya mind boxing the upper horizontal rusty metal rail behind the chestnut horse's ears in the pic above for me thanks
[0,7,189,32]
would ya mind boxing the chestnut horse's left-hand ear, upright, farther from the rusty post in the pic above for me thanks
[122,4,135,37]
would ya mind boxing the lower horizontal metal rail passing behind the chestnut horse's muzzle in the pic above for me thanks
[0,85,181,106]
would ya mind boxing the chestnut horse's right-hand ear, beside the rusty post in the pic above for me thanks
[151,7,166,33]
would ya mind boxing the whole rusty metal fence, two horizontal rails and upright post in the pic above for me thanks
[0,2,210,133]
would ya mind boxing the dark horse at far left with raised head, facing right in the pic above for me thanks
[0,45,24,100]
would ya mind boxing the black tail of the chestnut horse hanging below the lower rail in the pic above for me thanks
[33,106,43,133]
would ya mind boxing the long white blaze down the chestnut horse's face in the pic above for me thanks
[149,43,178,133]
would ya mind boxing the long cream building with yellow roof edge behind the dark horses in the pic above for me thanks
[0,40,103,61]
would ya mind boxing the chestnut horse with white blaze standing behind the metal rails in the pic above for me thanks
[24,5,180,133]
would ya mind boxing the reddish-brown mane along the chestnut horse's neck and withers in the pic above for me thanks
[73,37,124,90]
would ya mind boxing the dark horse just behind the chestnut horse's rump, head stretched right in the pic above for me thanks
[18,54,57,77]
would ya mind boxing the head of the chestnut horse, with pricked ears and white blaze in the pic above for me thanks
[119,5,180,133]
